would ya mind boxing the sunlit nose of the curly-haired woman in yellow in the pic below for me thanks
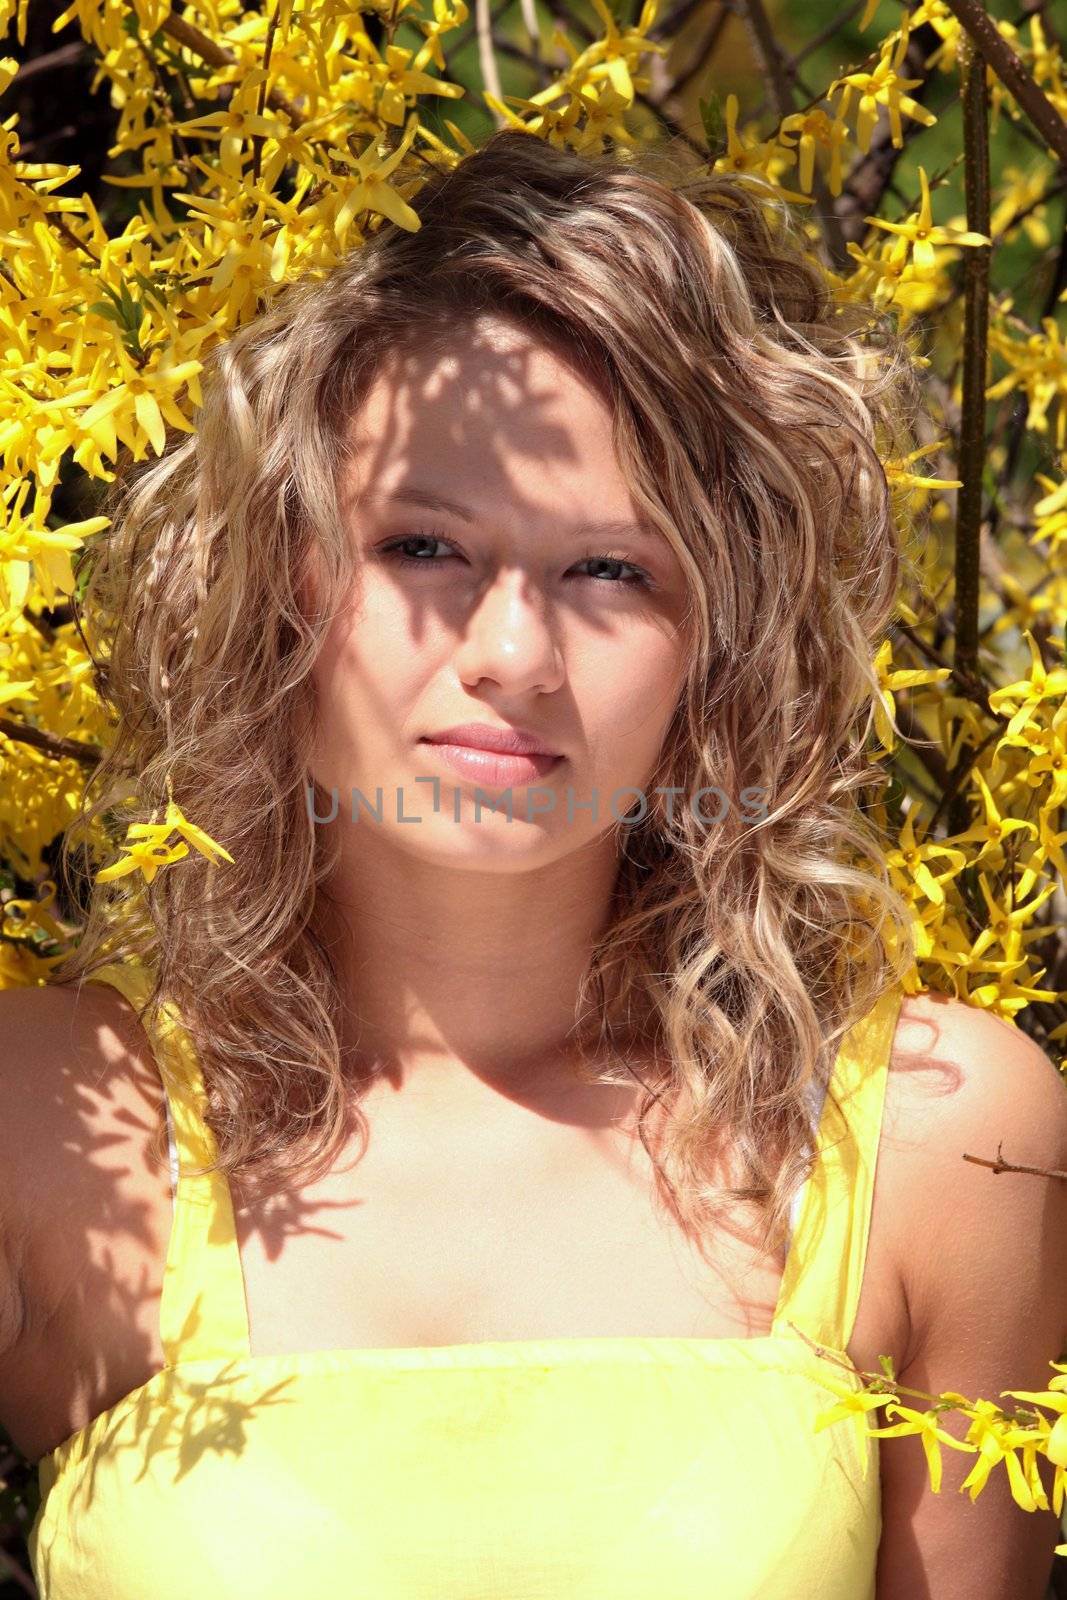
[456,568,563,694]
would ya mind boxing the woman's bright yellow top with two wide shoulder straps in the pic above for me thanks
[29,966,901,1600]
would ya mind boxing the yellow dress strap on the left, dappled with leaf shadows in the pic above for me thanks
[86,962,250,1368]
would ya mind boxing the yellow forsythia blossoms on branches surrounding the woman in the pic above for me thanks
[0,0,1067,1550]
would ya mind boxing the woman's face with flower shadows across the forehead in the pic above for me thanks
[312,318,686,870]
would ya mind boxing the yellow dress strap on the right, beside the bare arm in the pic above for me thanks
[773,984,904,1354]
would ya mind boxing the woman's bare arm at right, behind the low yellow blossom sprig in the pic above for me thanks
[877,997,1067,1600]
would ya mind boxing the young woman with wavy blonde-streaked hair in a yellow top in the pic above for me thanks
[0,133,1067,1600]
